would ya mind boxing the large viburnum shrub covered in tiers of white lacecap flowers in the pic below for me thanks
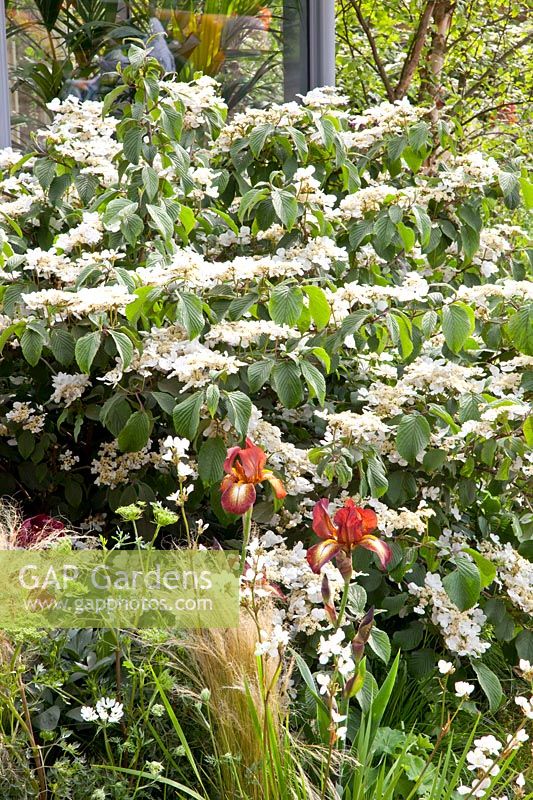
[0,47,533,705]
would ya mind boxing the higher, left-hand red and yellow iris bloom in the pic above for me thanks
[220,439,287,515]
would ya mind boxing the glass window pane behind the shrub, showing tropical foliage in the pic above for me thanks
[4,0,306,146]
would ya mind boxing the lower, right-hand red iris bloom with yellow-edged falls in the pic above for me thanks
[307,498,392,574]
